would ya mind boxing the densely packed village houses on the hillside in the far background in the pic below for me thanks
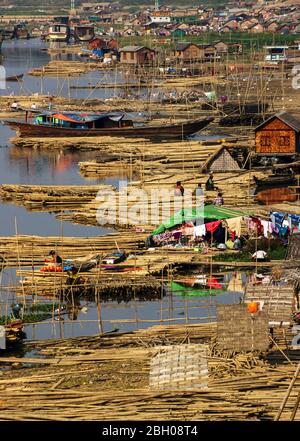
[71,1,300,36]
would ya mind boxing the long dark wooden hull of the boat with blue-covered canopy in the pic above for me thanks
[3,118,214,139]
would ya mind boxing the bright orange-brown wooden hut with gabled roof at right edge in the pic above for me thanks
[255,112,300,156]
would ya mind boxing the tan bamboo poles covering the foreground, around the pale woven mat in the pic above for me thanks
[0,325,300,420]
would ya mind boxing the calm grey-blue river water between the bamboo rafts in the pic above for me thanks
[0,39,247,339]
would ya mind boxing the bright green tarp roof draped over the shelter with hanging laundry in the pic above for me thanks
[152,204,247,236]
